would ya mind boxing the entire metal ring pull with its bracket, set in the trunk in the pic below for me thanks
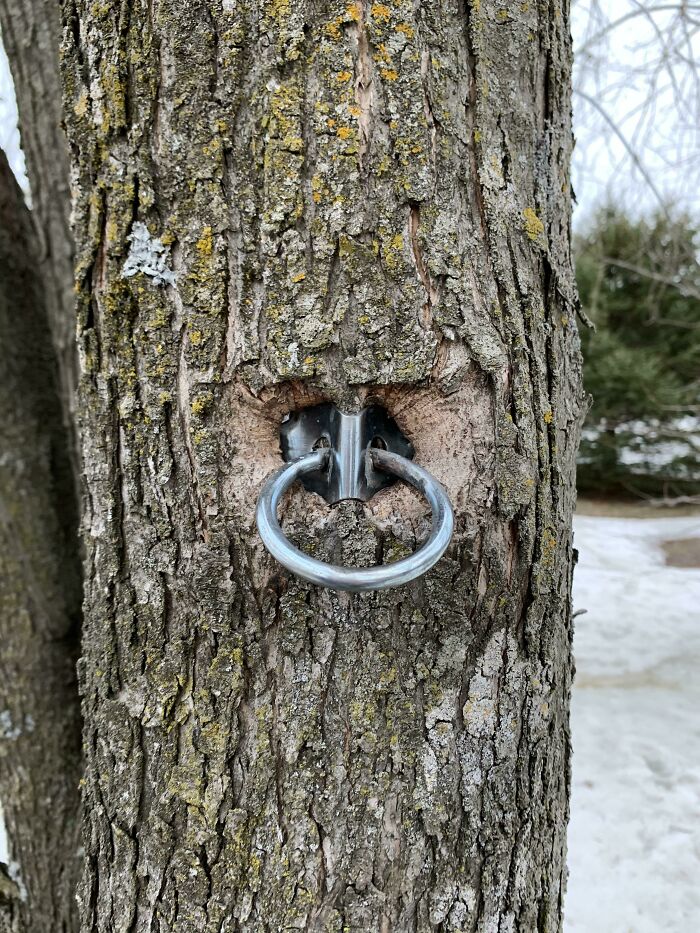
[256,404,454,592]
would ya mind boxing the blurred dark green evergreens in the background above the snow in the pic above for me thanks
[575,208,700,498]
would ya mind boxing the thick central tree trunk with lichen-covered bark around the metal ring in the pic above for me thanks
[57,0,583,933]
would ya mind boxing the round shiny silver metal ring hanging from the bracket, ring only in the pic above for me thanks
[255,447,454,593]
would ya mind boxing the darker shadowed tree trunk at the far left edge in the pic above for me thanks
[0,153,81,933]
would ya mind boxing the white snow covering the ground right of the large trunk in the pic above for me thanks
[565,516,700,933]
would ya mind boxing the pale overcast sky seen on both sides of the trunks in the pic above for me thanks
[0,0,700,226]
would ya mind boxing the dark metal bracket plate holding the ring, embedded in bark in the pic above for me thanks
[280,402,414,504]
